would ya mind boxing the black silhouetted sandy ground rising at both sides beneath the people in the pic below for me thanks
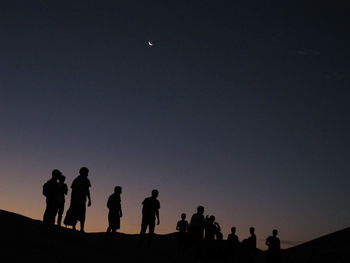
[0,210,350,263]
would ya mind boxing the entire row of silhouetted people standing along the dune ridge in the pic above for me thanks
[43,167,280,263]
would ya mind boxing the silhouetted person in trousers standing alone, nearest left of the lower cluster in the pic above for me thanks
[140,189,160,235]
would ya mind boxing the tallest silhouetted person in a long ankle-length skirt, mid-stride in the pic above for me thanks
[67,167,91,232]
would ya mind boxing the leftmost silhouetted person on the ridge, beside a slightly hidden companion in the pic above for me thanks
[43,169,62,224]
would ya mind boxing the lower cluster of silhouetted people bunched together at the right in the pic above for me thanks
[176,206,280,263]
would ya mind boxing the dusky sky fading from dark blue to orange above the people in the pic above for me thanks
[0,0,350,249]
